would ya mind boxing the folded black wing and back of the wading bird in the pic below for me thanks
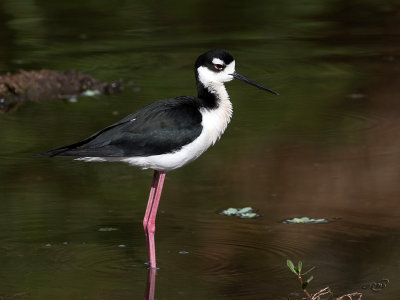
[38,96,202,157]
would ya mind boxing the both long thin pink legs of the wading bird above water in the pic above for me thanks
[143,171,165,269]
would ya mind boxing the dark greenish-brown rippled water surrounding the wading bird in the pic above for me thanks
[0,0,400,299]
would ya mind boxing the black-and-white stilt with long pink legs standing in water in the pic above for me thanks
[39,50,278,268]
